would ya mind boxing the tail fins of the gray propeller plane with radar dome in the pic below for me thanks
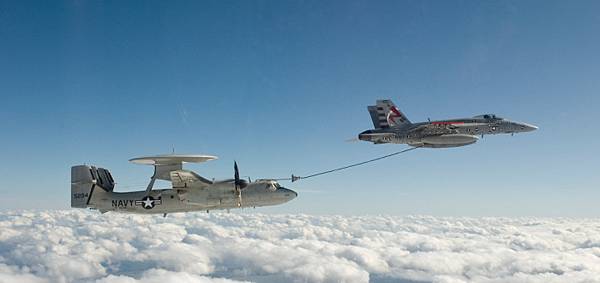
[71,165,115,208]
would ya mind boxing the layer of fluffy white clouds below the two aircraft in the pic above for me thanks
[0,210,600,283]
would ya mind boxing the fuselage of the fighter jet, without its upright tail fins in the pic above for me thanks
[359,115,537,148]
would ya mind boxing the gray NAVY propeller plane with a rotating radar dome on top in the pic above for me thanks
[71,154,298,216]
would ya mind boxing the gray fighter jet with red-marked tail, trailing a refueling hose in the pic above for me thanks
[358,100,538,148]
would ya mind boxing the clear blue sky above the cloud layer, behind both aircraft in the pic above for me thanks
[0,1,600,217]
